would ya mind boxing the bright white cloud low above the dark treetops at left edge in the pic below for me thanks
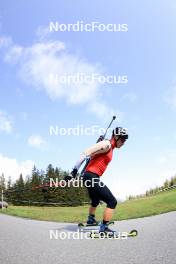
[0,154,34,181]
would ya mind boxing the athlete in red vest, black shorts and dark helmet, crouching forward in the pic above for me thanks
[71,127,128,233]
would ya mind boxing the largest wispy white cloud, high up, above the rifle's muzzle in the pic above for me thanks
[0,35,119,119]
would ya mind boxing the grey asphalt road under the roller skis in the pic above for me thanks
[0,212,176,264]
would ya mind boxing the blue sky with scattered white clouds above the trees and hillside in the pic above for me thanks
[0,0,176,198]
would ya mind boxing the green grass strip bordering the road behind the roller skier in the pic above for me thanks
[0,190,176,222]
